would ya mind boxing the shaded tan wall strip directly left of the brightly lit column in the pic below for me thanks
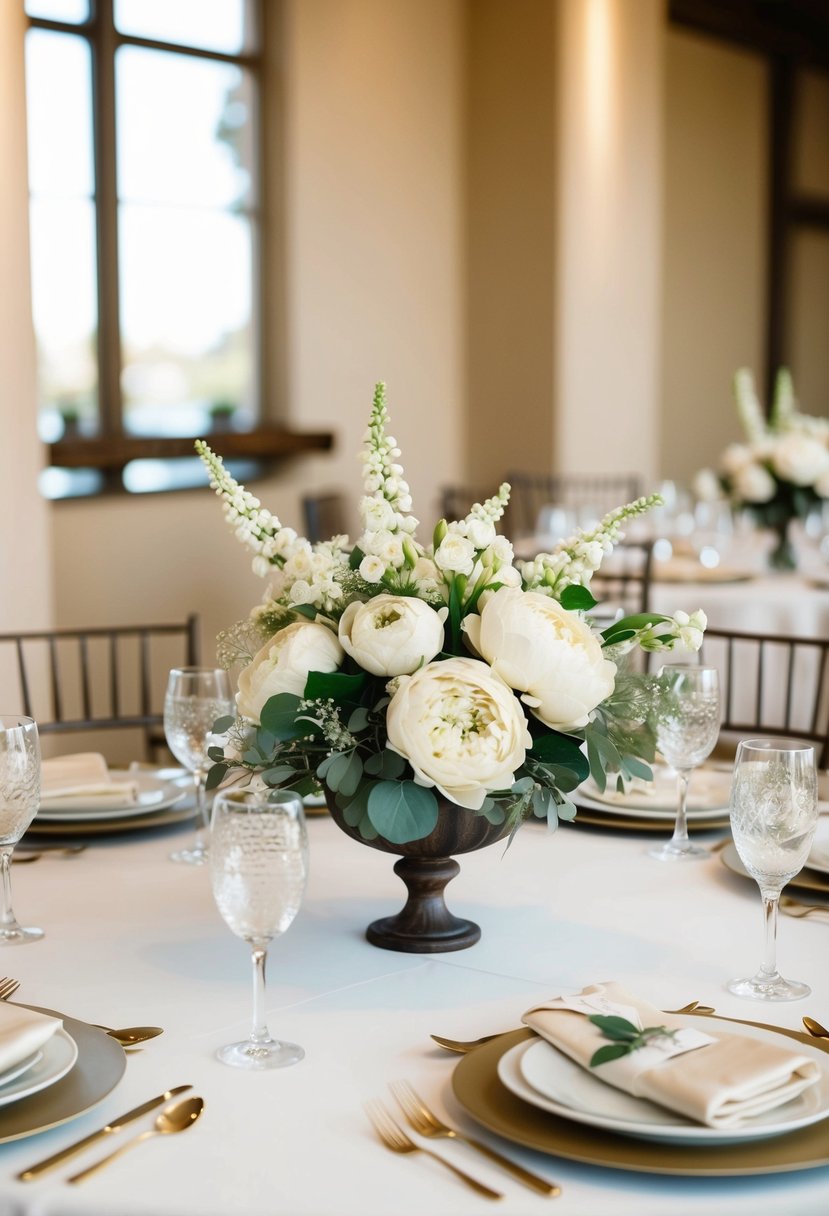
[463,0,556,483]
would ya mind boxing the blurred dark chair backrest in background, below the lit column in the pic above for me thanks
[507,473,642,536]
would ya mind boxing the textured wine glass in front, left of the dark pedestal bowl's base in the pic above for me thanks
[210,789,308,1069]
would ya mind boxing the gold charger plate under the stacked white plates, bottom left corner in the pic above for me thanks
[0,1004,126,1143]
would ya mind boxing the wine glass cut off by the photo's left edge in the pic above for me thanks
[0,714,44,946]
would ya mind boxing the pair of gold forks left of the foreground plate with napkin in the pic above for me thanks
[366,1081,562,1199]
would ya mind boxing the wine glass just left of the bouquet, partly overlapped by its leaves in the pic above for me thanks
[164,668,236,866]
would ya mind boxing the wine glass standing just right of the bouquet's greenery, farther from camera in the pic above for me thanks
[650,665,720,861]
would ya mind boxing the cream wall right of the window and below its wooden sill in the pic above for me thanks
[51,0,463,655]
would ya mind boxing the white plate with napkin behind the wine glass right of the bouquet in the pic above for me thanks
[575,765,732,821]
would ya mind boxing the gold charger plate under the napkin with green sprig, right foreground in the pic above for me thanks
[452,1015,829,1177]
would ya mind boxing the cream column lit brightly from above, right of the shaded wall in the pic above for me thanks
[554,0,665,483]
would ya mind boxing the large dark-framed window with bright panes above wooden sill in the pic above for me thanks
[26,0,261,492]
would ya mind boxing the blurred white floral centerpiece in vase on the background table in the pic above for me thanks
[694,367,829,569]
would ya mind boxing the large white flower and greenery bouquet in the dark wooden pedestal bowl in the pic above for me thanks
[196,384,705,844]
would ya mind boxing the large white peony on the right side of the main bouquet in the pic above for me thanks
[463,587,616,731]
